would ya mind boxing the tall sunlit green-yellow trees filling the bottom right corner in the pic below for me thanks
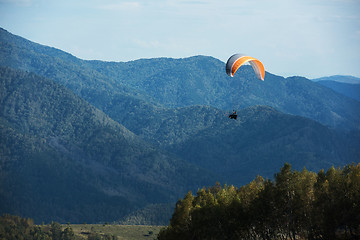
[158,164,360,240]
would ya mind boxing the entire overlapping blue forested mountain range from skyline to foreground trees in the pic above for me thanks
[0,29,360,224]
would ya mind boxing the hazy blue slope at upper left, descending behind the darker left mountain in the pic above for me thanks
[0,28,159,110]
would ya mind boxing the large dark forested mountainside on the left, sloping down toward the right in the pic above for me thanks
[0,67,213,223]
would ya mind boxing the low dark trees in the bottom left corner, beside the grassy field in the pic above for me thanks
[0,214,116,240]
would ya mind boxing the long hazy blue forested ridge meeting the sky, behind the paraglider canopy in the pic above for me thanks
[0,29,360,131]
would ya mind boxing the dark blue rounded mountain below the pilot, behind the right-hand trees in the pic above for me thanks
[169,106,360,184]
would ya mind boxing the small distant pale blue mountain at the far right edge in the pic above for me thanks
[318,80,360,101]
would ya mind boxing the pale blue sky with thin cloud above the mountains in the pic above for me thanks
[0,0,360,78]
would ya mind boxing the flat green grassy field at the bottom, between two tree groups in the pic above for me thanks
[53,224,163,240]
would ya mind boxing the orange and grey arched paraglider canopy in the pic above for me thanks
[226,53,265,81]
